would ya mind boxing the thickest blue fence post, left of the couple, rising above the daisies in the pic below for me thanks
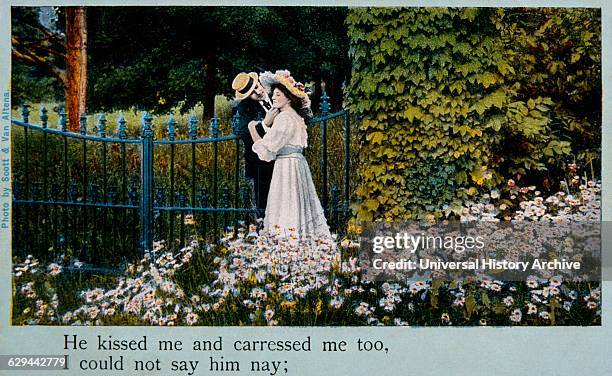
[140,112,153,251]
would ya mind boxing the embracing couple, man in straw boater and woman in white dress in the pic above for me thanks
[232,71,331,239]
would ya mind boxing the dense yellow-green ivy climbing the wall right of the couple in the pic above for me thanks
[347,8,509,221]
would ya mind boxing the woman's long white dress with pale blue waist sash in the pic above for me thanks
[253,111,331,239]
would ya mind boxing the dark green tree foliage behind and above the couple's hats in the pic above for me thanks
[79,7,348,114]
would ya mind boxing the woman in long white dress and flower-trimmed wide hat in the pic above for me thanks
[249,72,331,239]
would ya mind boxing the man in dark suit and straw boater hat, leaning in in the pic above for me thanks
[232,72,278,218]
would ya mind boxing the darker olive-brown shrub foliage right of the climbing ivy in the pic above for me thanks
[493,8,601,181]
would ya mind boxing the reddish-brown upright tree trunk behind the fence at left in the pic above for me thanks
[65,7,87,131]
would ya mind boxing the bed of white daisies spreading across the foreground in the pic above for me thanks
[13,181,601,326]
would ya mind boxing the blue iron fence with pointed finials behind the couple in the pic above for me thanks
[12,94,351,266]
